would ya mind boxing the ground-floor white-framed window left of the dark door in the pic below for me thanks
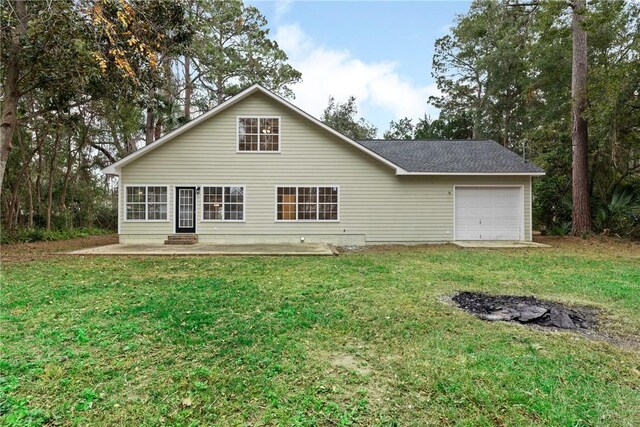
[126,185,168,221]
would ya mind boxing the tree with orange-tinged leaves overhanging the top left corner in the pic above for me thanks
[0,0,191,194]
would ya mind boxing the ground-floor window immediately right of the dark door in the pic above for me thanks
[202,186,244,221]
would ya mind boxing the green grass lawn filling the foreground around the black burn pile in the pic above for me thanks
[0,245,640,426]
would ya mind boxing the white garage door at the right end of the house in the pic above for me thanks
[455,187,524,240]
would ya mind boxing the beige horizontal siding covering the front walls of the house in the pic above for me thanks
[120,93,531,243]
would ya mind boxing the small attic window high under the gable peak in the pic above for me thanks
[238,117,280,153]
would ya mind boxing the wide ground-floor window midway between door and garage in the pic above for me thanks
[276,187,338,221]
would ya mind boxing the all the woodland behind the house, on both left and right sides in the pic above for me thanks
[0,0,640,237]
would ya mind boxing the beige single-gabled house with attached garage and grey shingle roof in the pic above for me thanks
[103,85,544,245]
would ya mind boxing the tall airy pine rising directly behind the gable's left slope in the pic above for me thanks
[183,0,301,116]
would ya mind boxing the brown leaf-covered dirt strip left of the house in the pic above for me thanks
[0,234,118,265]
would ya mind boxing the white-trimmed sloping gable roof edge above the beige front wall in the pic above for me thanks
[102,84,402,175]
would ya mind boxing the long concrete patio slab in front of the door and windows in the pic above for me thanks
[67,243,336,256]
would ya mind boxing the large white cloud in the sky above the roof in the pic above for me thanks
[275,24,438,133]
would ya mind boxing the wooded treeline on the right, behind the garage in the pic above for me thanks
[385,0,640,237]
